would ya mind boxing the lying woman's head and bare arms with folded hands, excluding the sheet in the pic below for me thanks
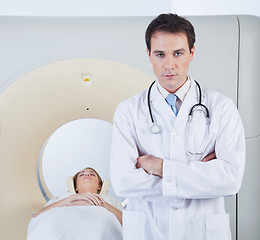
[33,167,122,224]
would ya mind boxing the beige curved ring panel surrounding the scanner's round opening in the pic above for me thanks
[0,58,153,239]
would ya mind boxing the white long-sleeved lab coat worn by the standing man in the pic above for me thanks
[110,80,245,240]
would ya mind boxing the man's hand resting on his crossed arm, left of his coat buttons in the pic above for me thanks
[136,155,163,177]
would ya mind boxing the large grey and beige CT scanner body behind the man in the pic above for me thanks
[0,16,260,240]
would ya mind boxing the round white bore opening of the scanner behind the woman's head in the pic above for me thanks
[37,119,112,201]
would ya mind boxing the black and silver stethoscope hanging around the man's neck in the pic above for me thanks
[147,81,210,155]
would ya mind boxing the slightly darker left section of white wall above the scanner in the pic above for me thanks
[0,0,171,16]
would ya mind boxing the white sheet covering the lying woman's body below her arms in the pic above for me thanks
[27,206,123,240]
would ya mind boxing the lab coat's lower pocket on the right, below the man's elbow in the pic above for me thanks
[206,214,231,240]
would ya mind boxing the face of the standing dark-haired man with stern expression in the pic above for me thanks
[147,32,195,93]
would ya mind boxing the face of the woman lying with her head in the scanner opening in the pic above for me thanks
[76,168,101,193]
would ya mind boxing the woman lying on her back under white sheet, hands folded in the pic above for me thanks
[27,168,122,240]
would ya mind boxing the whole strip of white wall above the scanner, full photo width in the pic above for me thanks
[0,0,260,16]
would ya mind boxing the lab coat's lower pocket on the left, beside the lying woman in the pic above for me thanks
[123,210,145,240]
